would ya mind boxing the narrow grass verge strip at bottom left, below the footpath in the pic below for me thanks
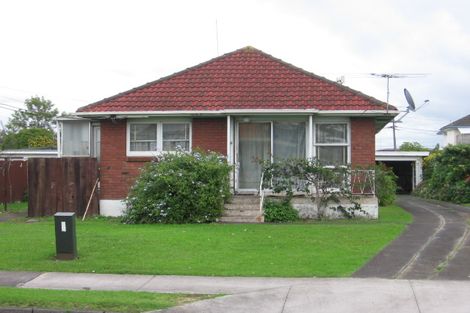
[0,287,209,312]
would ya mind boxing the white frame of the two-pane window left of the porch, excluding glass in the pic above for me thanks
[126,119,193,157]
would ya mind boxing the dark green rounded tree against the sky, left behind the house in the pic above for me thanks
[6,96,59,133]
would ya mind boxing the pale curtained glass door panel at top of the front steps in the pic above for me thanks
[238,122,272,191]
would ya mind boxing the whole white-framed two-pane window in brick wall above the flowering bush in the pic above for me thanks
[127,122,191,156]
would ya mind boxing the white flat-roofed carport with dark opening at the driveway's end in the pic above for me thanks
[375,150,429,193]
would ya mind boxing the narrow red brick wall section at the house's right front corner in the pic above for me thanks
[351,118,375,167]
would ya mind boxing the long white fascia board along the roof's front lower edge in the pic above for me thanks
[74,109,400,118]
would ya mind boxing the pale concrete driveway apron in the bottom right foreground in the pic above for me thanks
[158,279,470,313]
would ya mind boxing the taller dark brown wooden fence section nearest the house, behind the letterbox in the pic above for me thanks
[28,158,99,217]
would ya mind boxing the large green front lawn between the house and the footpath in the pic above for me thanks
[0,206,411,277]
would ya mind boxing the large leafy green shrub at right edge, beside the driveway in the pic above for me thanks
[415,144,470,203]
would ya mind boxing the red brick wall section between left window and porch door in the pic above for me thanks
[192,117,227,155]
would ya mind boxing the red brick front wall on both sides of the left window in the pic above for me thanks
[100,118,227,200]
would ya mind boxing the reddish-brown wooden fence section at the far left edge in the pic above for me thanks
[0,159,28,203]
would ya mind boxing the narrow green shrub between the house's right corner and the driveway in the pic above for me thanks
[375,164,398,206]
